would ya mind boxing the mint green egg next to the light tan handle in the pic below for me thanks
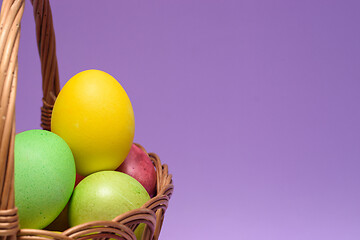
[14,130,76,229]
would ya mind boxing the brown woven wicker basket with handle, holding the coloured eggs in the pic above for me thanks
[0,0,174,239]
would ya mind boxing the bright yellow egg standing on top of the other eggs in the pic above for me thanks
[51,70,135,176]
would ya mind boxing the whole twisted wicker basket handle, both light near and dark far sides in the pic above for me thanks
[0,0,60,237]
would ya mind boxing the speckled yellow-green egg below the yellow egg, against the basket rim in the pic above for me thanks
[69,171,150,226]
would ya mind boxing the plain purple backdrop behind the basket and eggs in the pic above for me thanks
[16,0,360,240]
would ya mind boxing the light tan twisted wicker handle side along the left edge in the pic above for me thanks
[0,0,24,239]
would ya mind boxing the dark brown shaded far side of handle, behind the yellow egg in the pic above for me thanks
[31,0,60,131]
